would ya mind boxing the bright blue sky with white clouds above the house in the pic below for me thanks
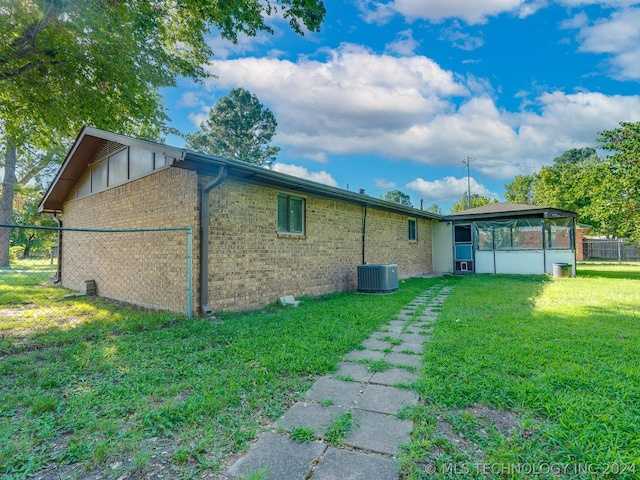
[163,0,640,212]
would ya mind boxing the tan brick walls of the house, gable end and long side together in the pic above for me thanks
[61,168,432,313]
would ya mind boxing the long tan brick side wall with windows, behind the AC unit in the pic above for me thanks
[201,178,431,310]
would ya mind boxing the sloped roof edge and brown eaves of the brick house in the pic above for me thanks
[38,127,442,220]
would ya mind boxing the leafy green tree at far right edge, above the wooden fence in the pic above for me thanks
[588,122,640,241]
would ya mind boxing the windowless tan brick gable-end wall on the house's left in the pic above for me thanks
[61,168,198,312]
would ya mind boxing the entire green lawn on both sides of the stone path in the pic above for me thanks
[0,264,640,479]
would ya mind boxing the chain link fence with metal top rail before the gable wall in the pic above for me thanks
[0,225,193,316]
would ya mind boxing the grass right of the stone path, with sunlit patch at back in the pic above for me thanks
[400,264,640,479]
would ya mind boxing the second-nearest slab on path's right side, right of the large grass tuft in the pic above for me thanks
[339,410,413,456]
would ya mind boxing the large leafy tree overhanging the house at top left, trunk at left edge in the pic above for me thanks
[0,0,325,265]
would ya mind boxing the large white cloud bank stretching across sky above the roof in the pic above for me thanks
[192,44,640,181]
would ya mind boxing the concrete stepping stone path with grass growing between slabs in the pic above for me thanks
[226,281,453,480]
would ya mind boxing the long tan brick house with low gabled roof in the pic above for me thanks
[39,127,440,313]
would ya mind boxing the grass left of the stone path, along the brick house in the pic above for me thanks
[0,272,440,478]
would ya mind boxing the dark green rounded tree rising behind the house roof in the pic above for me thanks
[186,88,280,166]
